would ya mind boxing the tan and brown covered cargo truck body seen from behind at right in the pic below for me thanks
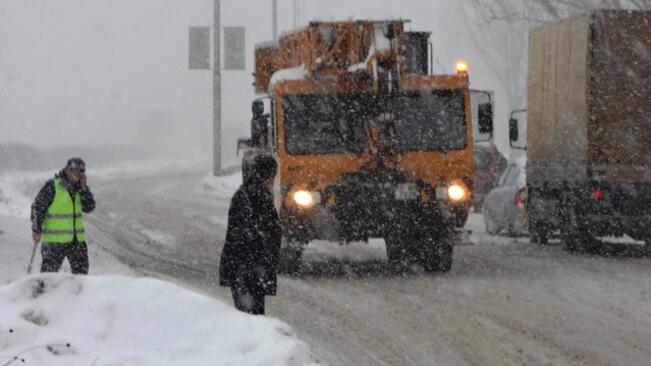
[516,10,651,250]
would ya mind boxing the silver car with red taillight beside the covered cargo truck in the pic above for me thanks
[483,157,528,236]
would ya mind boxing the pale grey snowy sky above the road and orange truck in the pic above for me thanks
[0,0,506,165]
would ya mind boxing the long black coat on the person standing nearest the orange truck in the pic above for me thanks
[219,178,282,295]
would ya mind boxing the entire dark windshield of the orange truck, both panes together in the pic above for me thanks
[283,90,466,155]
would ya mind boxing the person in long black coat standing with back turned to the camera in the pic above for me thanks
[219,155,282,315]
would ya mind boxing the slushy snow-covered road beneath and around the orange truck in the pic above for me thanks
[89,172,651,366]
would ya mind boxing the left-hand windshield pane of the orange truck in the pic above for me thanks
[283,94,369,154]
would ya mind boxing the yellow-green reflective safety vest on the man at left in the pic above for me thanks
[42,178,86,244]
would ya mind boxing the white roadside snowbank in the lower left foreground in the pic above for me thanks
[0,274,311,366]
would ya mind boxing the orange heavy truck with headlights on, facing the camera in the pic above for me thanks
[238,20,492,272]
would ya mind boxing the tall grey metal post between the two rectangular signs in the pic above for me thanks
[212,0,222,176]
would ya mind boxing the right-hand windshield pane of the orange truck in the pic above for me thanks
[393,90,466,151]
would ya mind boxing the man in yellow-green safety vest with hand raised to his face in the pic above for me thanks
[32,158,95,274]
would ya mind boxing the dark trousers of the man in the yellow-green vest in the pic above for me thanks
[41,240,88,274]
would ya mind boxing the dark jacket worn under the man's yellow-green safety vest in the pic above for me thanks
[31,171,95,234]
